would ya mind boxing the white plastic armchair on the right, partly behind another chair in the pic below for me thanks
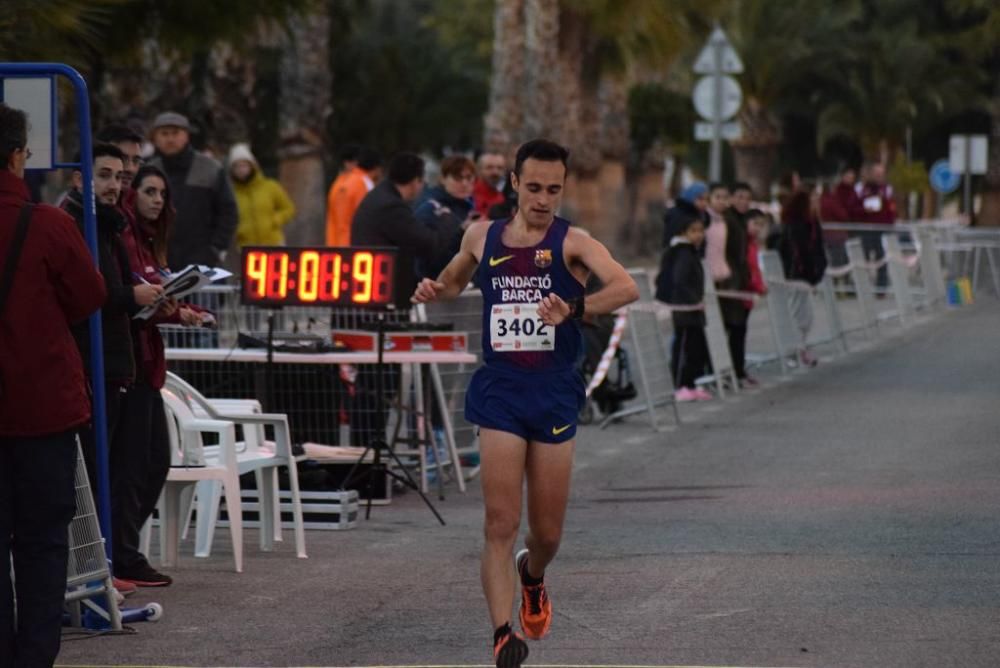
[165,372,307,559]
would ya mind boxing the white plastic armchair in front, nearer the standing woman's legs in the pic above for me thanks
[160,388,243,573]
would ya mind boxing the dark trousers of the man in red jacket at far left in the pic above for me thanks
[0,432,76,668]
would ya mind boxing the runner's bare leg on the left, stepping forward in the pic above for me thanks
[479,429,528,629]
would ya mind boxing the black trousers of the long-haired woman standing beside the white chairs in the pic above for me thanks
[110,380,170,574]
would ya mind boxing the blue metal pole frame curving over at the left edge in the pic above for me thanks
[0,63,111,561]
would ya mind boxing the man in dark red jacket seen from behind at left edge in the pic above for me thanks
[0,104,105,668]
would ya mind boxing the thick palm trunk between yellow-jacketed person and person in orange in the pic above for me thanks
[279,8,332,245]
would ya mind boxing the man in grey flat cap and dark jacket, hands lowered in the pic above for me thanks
[150,111,239,271]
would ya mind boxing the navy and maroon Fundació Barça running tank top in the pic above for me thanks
[478,217,584,372]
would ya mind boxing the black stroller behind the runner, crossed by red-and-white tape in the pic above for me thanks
[578,315,636,424]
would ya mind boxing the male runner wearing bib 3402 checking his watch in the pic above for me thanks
[412,139,639,668]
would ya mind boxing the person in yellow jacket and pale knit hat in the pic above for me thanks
[229,144,295,248]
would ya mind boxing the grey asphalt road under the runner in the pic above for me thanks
[59,299,1000,667]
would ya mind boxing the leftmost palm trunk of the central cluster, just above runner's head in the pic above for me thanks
[483,0,525,159]
